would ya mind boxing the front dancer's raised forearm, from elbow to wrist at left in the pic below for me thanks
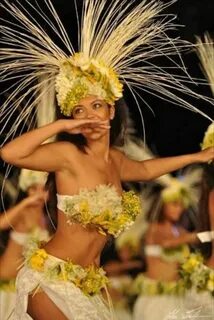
[1,120,63,163]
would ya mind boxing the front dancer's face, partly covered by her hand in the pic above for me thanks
[72,96,114,140]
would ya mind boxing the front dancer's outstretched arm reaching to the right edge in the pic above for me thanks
[113,148,214,181]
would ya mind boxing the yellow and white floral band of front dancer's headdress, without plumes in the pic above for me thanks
[56,52,123,116]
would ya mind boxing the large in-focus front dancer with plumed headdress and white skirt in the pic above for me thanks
[0,0,214,320]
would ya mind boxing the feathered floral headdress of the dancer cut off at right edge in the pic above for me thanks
[197,34,214,150]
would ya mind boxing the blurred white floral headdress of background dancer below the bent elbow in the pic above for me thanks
[19,169,48,191]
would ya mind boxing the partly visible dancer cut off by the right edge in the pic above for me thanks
[181,34,214,320]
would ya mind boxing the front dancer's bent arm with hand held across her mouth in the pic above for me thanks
[1,120,103,172]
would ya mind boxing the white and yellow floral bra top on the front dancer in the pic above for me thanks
[57,185,141,237]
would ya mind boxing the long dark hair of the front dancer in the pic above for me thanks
[46,99,129,226]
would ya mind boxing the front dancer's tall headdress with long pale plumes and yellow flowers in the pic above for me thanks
[0,0,214,144]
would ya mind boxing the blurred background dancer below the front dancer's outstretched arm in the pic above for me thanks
[133,171,206,320]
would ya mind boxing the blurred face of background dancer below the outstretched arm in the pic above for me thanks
[163,201,184,222]
